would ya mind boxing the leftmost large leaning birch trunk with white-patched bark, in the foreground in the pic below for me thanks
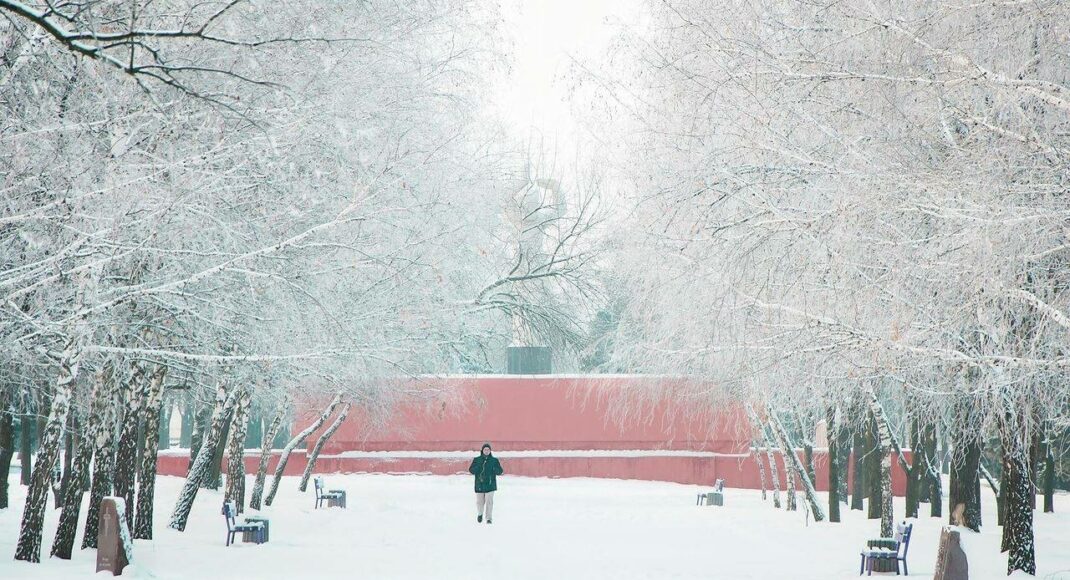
[14,303,89,562]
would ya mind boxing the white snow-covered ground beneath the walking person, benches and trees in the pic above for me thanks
[0,475,1070,580]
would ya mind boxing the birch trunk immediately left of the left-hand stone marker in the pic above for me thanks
[81,362,122,550]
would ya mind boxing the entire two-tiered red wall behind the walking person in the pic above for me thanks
[159,376,906,495]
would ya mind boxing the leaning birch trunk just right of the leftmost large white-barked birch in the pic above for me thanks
[51,365,111,560]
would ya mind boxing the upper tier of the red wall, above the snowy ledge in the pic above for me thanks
[293,376,749,454]
